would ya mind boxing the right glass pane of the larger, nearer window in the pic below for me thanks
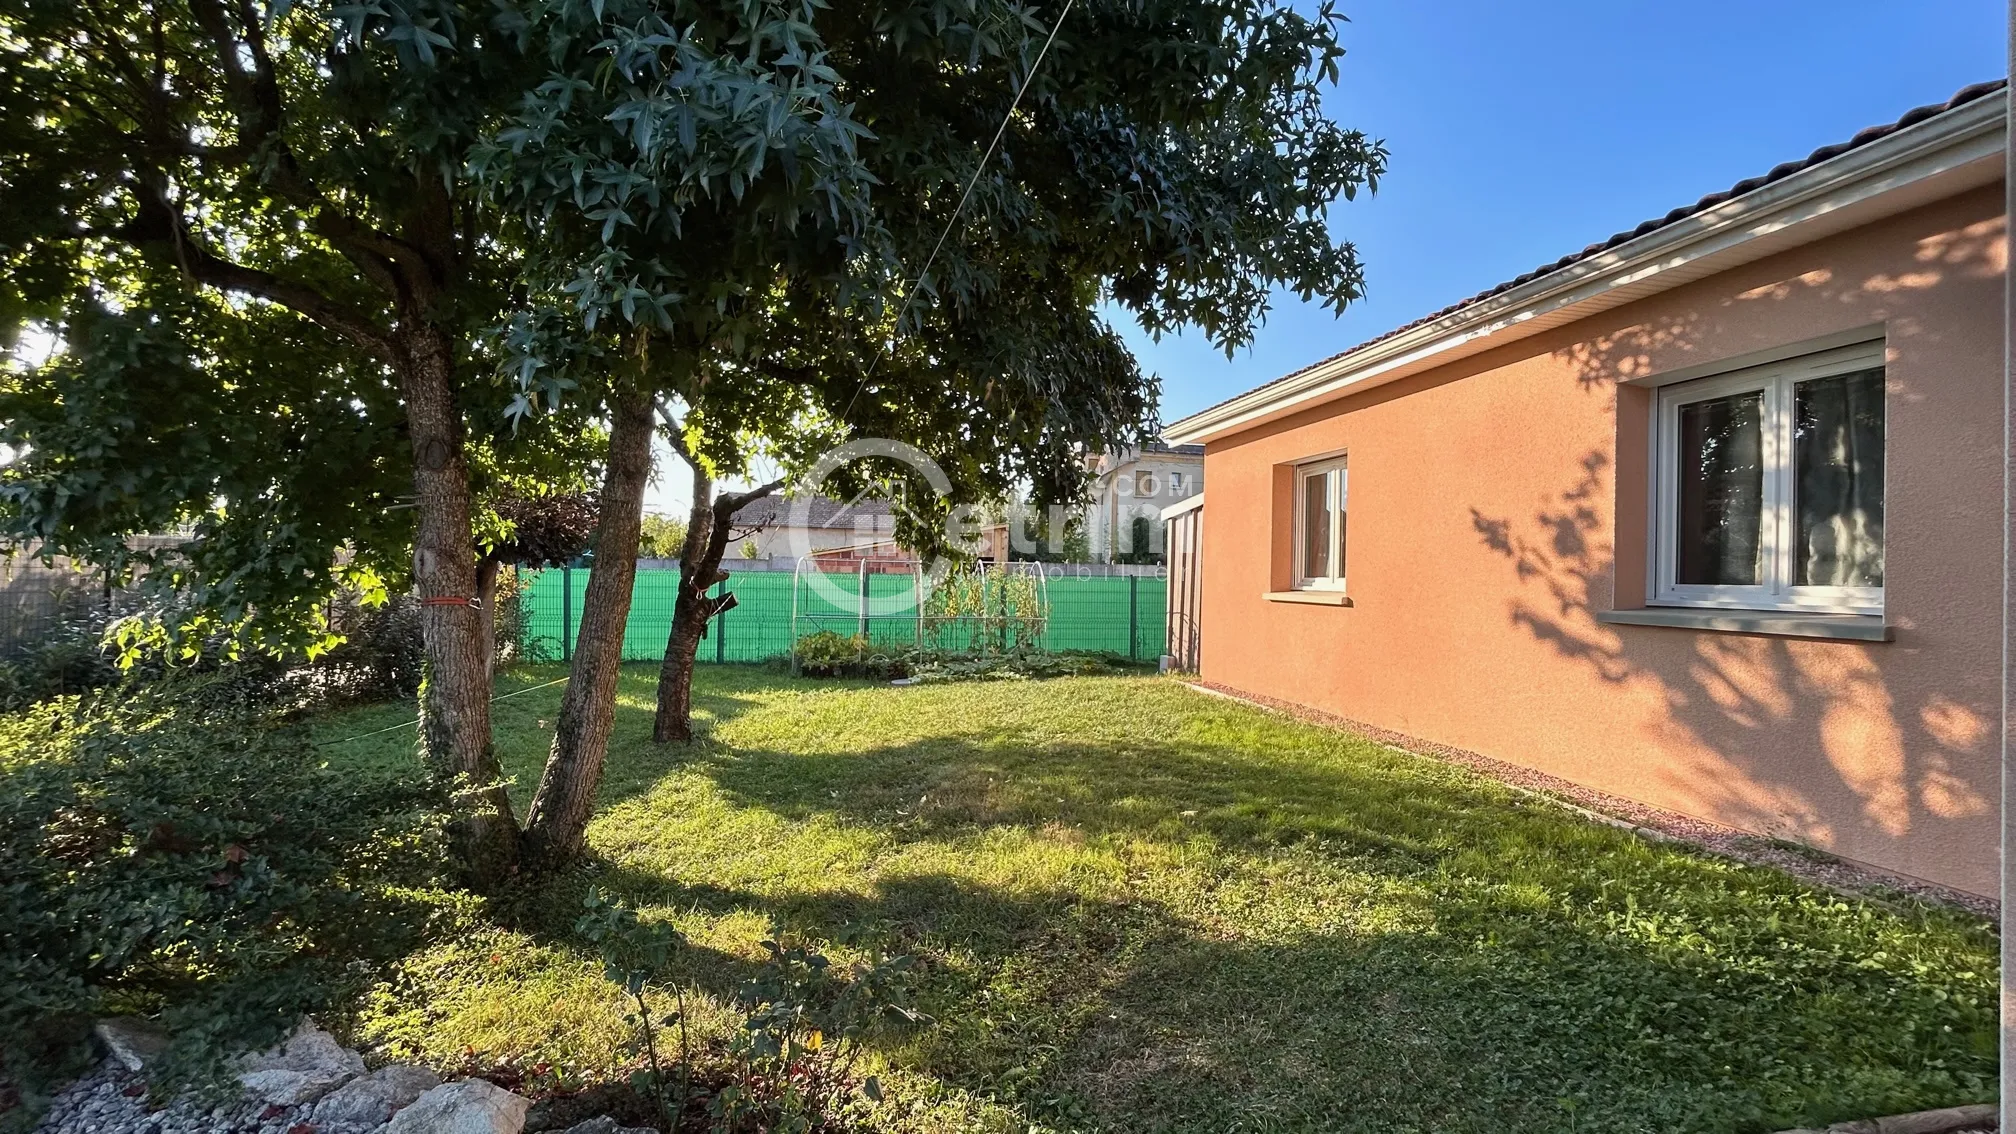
[1792,367,1883,587]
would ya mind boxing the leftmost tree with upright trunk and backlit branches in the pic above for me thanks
[0,0,560,878]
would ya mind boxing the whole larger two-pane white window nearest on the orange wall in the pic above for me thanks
[1653,343,1883,613]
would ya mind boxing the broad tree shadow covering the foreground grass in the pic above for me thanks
[508,851,1994,1134]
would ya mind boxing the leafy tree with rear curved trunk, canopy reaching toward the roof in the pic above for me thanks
[514,0,1385,739]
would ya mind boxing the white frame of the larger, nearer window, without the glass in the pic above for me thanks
[1651,341,1889,615]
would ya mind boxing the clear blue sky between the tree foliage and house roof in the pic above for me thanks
[1121,0,2008,422]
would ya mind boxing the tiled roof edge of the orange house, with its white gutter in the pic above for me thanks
[1163,79,2008,448]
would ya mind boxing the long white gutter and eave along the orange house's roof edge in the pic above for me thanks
[1161,95,2008,444]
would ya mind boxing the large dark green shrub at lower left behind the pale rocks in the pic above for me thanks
[0,678,444,1090]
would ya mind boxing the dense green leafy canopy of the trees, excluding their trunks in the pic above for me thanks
[0,0,1385,637]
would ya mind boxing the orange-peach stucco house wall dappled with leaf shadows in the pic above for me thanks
[1202,186,2006,894]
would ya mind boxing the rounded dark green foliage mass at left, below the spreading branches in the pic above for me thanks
[0,276,413,650]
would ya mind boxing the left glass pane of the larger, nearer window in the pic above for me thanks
[1675,391,1764,585]
